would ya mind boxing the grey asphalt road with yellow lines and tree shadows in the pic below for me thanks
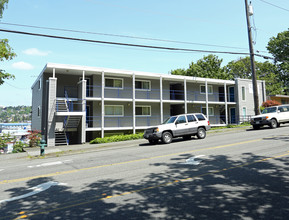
[0,126,289,220]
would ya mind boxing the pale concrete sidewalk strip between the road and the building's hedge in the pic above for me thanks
[0,126,250,161]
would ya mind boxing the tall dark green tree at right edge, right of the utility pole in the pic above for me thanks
[267,29,289,94]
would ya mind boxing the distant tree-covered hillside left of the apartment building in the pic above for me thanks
[0,106,31,123]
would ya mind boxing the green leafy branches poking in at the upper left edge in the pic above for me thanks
[0,0,16,85]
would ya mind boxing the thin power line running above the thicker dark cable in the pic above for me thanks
[0,22,250,52]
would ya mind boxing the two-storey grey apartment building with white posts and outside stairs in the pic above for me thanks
[32,63,266,146]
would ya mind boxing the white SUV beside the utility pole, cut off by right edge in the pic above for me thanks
[250,105,289,129]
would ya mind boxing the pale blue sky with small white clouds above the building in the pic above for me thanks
[0,0,289,106]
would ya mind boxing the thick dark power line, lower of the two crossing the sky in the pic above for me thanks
[0,29,271,59]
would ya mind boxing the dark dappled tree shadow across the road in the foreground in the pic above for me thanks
[0,150,289,220]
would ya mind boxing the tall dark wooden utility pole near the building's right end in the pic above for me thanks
[245,0,260,115]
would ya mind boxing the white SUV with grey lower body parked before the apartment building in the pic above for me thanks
[144,113,211,144]
